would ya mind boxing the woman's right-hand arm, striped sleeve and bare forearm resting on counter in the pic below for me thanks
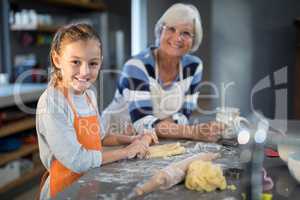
[155,59,223,142]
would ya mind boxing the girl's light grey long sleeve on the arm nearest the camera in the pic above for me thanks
[36,94,102,173]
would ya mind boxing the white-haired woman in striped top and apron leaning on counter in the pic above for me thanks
[102,3,224,143]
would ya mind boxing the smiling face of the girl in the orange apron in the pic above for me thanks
[53,40,102,94]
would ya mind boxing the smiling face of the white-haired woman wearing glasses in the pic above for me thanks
[160,23,194,57]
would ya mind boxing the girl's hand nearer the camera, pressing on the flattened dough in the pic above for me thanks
[125,140,148,159]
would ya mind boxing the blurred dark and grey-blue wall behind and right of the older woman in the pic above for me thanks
[148,0,300,118]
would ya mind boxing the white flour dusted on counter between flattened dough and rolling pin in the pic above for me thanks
[94,142,238,184]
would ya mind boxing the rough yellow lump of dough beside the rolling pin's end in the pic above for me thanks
[185,160,227,192]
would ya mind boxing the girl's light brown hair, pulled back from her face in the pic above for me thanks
[49,23,102,87]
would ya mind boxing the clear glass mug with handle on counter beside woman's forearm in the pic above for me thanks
[216,107,249,139]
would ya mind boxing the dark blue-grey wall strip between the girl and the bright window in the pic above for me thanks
[98,0,131,111]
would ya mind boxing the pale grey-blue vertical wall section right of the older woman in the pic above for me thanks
[210,0,254,110]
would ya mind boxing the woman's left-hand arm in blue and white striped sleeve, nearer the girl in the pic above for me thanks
[118,58,162,144]
